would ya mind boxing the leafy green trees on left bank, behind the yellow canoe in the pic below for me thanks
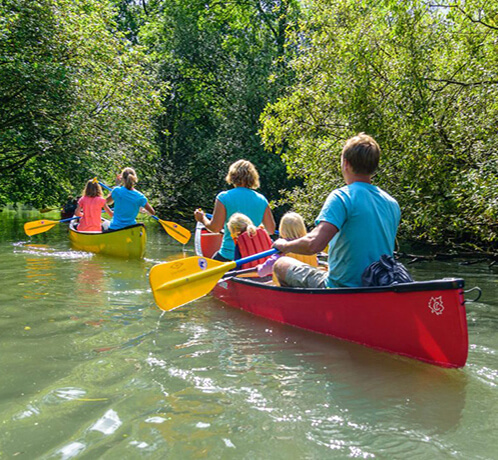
[0,0,163,205]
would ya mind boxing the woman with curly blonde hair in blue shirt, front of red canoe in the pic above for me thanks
[194,160,275,262]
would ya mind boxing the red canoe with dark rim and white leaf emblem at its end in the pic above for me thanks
[196,226,468,367]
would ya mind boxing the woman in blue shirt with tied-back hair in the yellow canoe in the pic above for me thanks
[106,168,156,230]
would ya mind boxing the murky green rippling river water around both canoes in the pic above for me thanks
[0,209,498,459]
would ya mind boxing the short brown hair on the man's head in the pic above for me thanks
[342,133,380,175]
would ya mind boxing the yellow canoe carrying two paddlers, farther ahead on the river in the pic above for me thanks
[69,222,147,259]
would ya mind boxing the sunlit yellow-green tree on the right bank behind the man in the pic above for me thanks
[262,0,498,245]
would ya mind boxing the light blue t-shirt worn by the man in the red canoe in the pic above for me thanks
[315,182,401,287]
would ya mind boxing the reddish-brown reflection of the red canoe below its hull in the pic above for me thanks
[227,311,469,433]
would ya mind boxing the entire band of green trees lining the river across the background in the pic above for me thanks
[0,0,498,252]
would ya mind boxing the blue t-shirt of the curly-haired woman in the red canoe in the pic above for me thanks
[216,187,268,260]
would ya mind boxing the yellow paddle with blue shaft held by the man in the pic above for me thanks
[149,249,278,310]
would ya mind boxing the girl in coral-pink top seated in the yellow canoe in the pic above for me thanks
[74,179,113,232]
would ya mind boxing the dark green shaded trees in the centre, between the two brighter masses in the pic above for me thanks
[136,0,298,217]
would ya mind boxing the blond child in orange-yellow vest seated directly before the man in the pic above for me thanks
[258,212,318,278]
